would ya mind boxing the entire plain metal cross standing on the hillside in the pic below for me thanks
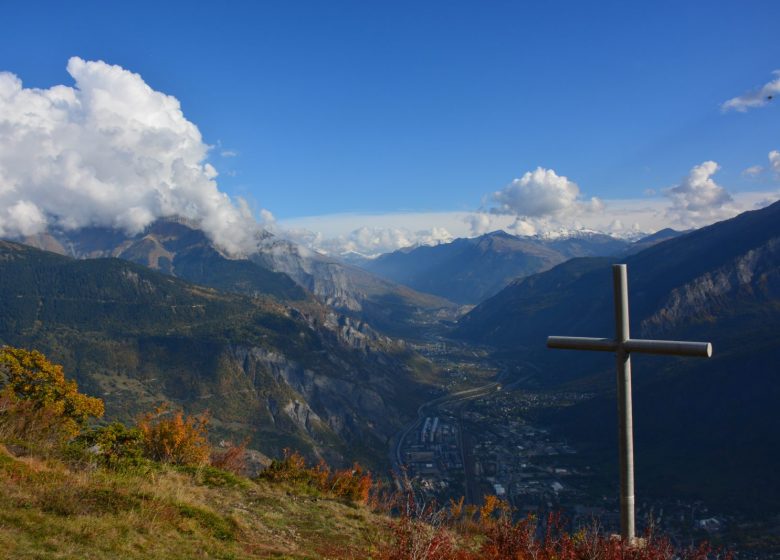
[547,264,712,543]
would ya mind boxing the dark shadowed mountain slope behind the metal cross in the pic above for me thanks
[456,203,780,515]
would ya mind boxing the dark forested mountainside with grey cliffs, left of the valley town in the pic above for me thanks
[0,242,430,464]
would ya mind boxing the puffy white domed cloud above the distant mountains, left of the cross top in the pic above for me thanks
[493,167,603,218]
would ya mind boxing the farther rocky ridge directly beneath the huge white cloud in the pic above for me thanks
[22,218,458,335]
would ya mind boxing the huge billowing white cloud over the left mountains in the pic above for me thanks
[0,57,259,253]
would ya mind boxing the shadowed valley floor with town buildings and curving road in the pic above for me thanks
[389,339,766,558]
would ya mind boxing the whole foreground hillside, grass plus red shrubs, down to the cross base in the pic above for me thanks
[0,446,730,560]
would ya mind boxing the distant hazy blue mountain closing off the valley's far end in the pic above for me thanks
[360,231,629,304]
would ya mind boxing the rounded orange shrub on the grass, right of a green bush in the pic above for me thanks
[138,405,211,465]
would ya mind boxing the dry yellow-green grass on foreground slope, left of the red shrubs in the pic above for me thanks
[0,447,387,560]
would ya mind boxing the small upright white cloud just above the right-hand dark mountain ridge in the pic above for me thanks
[665,161,734,226]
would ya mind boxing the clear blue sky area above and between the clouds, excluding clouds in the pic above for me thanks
[0,1,780,254]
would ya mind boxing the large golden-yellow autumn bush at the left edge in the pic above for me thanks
[0,346,105,445]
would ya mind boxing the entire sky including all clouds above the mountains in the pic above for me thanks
[0,0,780,254]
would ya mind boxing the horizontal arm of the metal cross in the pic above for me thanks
[547,336,712,358]
